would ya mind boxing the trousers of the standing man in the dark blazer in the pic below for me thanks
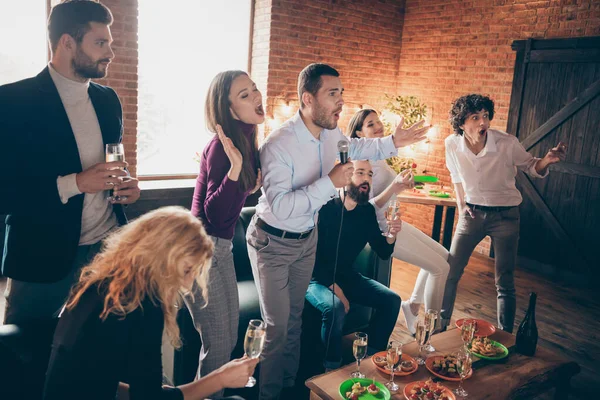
[4,242,102,324]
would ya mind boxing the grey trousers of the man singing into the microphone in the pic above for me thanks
[246,216,318,400]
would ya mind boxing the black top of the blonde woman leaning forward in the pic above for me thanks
[44,286,183,400]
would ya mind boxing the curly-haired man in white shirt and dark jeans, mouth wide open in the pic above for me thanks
[442,94,566,332]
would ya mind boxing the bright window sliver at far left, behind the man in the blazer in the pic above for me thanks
[0,0,48,85]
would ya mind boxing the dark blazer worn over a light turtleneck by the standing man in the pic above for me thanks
[0,67,126,282]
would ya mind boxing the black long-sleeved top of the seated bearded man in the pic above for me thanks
[313,198,394,290]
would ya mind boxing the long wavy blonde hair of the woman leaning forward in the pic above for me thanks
[67,207,213,348]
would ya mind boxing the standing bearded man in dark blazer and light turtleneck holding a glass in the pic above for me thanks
[0,0,140,323]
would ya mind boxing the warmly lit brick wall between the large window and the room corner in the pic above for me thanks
[251,0,404,138]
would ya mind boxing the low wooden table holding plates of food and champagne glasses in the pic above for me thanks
[306,329,580,400]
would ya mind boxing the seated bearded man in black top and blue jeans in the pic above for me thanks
[306,161,402,369]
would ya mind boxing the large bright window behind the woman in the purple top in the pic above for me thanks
[137,0,251,175]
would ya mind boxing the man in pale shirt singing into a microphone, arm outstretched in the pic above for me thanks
[246,64,428,400]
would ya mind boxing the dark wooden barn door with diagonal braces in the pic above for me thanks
[508,37,600,278]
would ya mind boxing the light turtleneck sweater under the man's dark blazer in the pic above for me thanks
[48,64,117,246]
